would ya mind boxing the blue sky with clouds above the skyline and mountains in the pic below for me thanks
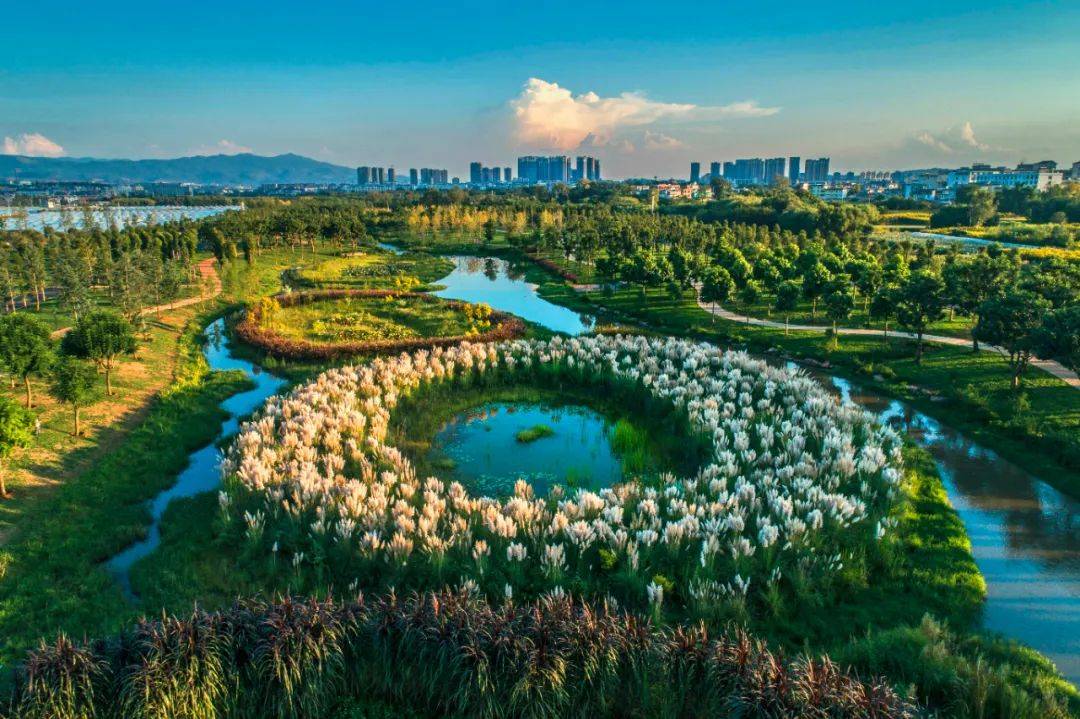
[0,0,1080,176]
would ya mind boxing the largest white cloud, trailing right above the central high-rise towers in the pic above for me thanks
[510,78,779,150]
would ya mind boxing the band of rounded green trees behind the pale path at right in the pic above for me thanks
[507,208,1080,385]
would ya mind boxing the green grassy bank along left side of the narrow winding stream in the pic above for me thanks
[0,308,246,664]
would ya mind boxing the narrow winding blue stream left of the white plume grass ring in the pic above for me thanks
[106,320,285,596]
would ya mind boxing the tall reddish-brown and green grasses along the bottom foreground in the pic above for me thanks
[9,591,916,719]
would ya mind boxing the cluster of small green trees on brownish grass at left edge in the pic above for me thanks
[0,311,136,498]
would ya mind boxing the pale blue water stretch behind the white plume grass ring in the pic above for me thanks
[434,257,594,335]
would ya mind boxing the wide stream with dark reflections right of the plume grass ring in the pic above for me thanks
[819,374,1080,683]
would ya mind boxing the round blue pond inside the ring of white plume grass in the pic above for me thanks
[432,402,622,497]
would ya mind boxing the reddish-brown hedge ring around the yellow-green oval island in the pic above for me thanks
[234,289,525,360]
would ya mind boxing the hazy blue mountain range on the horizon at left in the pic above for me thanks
[0,153,356,185]
